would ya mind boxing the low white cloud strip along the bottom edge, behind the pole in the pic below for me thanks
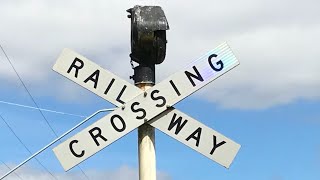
[0,165,171,180]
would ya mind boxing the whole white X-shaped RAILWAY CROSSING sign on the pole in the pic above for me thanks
[53,43,240,171]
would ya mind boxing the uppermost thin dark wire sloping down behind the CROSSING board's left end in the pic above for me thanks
[0,44,88,179]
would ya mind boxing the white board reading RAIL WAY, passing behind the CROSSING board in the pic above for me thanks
[55,45,240,167]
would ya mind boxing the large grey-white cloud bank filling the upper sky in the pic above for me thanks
[0,0,320,109]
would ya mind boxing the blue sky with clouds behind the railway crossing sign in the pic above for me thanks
[0,0,320,180]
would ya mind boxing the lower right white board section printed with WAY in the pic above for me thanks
[148,108,240,168]
